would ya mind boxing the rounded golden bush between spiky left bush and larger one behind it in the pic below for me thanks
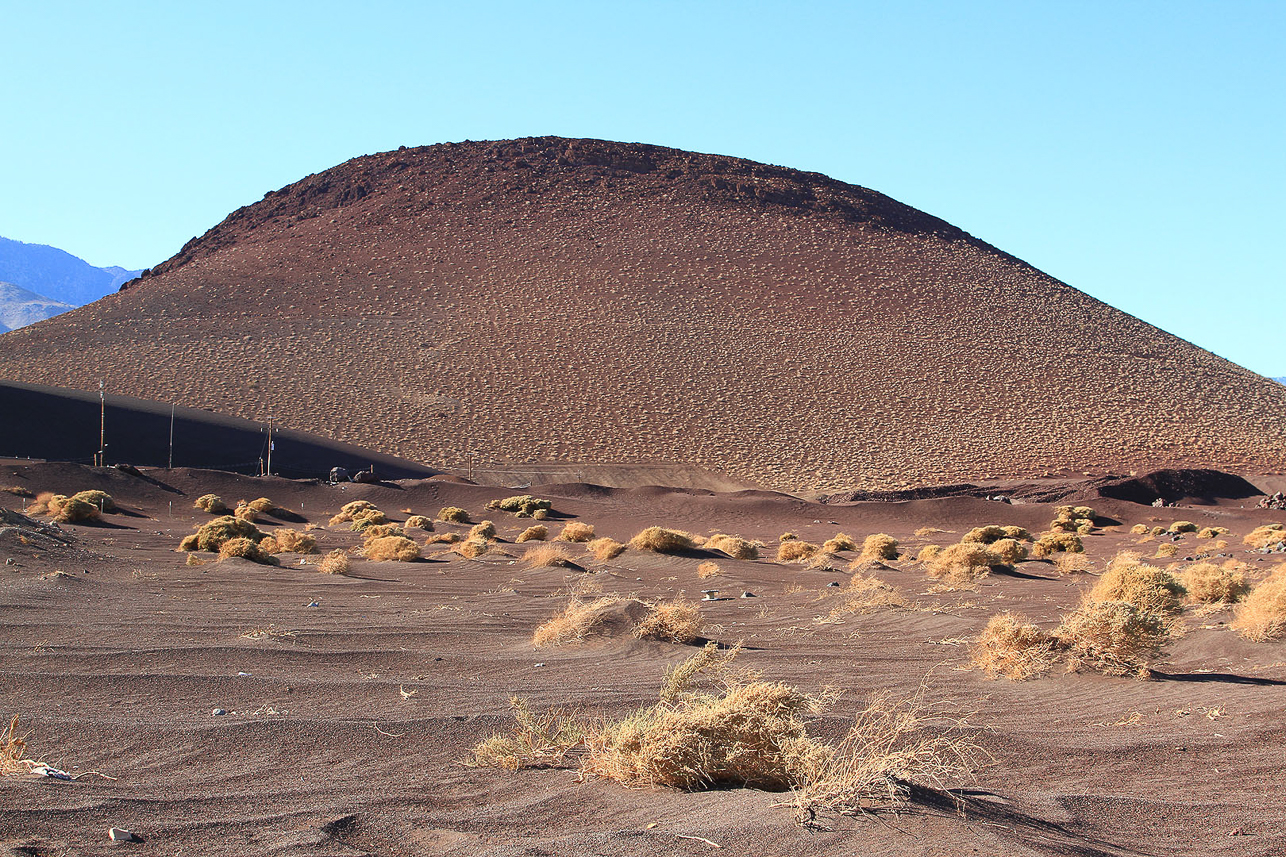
[1055,601,1170,676]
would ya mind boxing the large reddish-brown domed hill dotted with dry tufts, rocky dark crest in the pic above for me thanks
[0,138,1286,488]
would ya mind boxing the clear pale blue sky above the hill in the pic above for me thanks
[0,0,1286,376]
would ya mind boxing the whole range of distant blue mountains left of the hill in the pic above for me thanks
[0,237,140,333]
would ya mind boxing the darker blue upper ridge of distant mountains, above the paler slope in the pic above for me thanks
[0,237,141,306]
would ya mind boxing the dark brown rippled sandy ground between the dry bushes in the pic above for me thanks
[0,465,1286,856]
